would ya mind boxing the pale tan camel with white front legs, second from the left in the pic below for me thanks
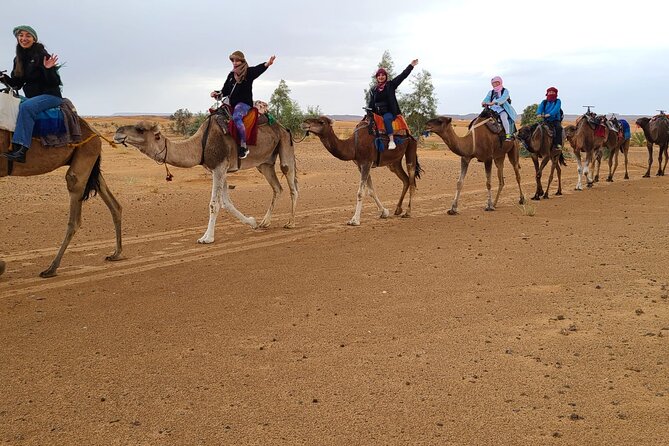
[114,117,298,244]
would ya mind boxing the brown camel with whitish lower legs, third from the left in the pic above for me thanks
[302,116,421,226]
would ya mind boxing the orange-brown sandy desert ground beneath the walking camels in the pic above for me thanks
[0,119,669,445]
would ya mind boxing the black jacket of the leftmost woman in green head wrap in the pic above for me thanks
[7,43,63,98]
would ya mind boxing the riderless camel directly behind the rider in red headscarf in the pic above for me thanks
[564,112,609,190]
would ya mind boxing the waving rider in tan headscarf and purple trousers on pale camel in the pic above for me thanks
[211,51,276,158]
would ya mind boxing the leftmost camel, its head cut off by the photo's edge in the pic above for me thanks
[0,119,122,277]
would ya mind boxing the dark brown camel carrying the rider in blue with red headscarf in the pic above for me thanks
[518,122,567,200]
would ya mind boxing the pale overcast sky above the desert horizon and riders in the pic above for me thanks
[0,0,669,115]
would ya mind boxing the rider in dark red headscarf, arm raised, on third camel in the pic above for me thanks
[367,59,418,150]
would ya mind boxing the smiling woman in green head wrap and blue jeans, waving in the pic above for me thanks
[1,25,63,163]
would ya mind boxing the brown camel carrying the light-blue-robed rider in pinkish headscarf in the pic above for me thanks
[425,110,525,215]
